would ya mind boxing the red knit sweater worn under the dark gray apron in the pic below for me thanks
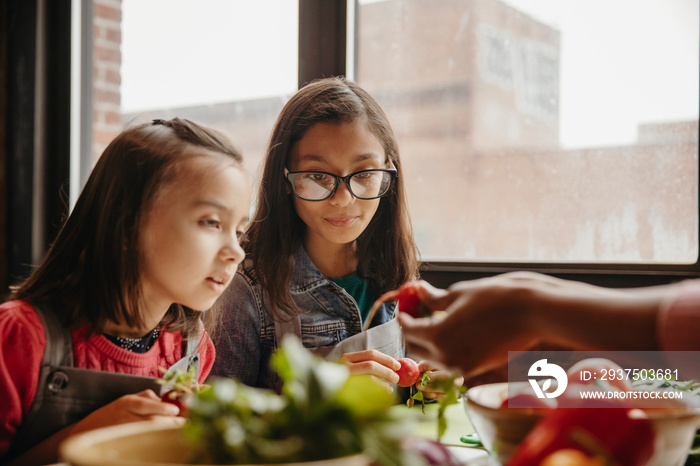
[0,301,214,457]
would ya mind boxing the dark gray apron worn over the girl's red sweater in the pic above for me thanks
[6,307,201,463]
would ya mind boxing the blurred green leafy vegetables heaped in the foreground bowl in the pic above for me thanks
[184,336,422,466]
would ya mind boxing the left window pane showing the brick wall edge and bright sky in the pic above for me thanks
[92,0,298,185]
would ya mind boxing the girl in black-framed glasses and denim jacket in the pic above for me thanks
[212,77,418,388]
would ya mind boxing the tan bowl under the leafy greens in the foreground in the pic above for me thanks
[60,421,371,466]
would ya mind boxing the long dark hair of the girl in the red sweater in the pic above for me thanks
[11,118,243,332]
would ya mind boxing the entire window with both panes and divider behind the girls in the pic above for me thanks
[79,0,700,286]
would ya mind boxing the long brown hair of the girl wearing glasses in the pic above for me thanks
[243,77,418,315]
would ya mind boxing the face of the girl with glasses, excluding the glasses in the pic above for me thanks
[287,119,386,253]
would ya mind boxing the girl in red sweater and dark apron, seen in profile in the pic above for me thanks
[0,118,250,464]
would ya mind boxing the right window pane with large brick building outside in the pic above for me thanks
[355,0,700,265]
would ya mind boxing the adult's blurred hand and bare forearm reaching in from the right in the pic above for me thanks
[399,272,673,378]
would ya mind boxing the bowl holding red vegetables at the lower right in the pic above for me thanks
[464,383,700,466]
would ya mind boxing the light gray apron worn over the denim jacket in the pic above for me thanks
[274,315,404,361]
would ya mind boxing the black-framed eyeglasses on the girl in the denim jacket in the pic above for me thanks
[284,164,396,202]
